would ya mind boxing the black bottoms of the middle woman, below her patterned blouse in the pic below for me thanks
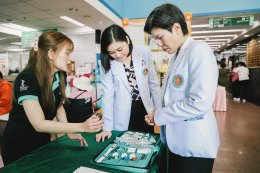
[128,98,154,133]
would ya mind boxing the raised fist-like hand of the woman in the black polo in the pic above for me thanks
[82,114,103,132]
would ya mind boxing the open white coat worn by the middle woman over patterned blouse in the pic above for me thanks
[100,46,160,131]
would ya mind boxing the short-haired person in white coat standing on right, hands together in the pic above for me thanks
[144,4,219,173]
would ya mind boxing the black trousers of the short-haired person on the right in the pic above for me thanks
[157,147,214,173]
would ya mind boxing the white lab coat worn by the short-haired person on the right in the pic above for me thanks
[154,38,219,158]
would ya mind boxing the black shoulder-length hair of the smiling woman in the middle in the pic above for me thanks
[101,25,133,72]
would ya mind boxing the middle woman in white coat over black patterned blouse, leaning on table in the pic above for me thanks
[96,25,160,141]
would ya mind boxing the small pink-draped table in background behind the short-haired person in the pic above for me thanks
[213,86,227,111]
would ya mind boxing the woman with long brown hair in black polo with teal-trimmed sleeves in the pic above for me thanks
[1,32,102,165]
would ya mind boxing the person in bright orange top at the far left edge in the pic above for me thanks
[0,71,12,115]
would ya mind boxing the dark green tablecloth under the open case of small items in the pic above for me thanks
[0,131,158,173]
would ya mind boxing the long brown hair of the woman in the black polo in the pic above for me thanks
[25,31,74,112]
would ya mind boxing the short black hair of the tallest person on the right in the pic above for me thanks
[144,3,188,35]
